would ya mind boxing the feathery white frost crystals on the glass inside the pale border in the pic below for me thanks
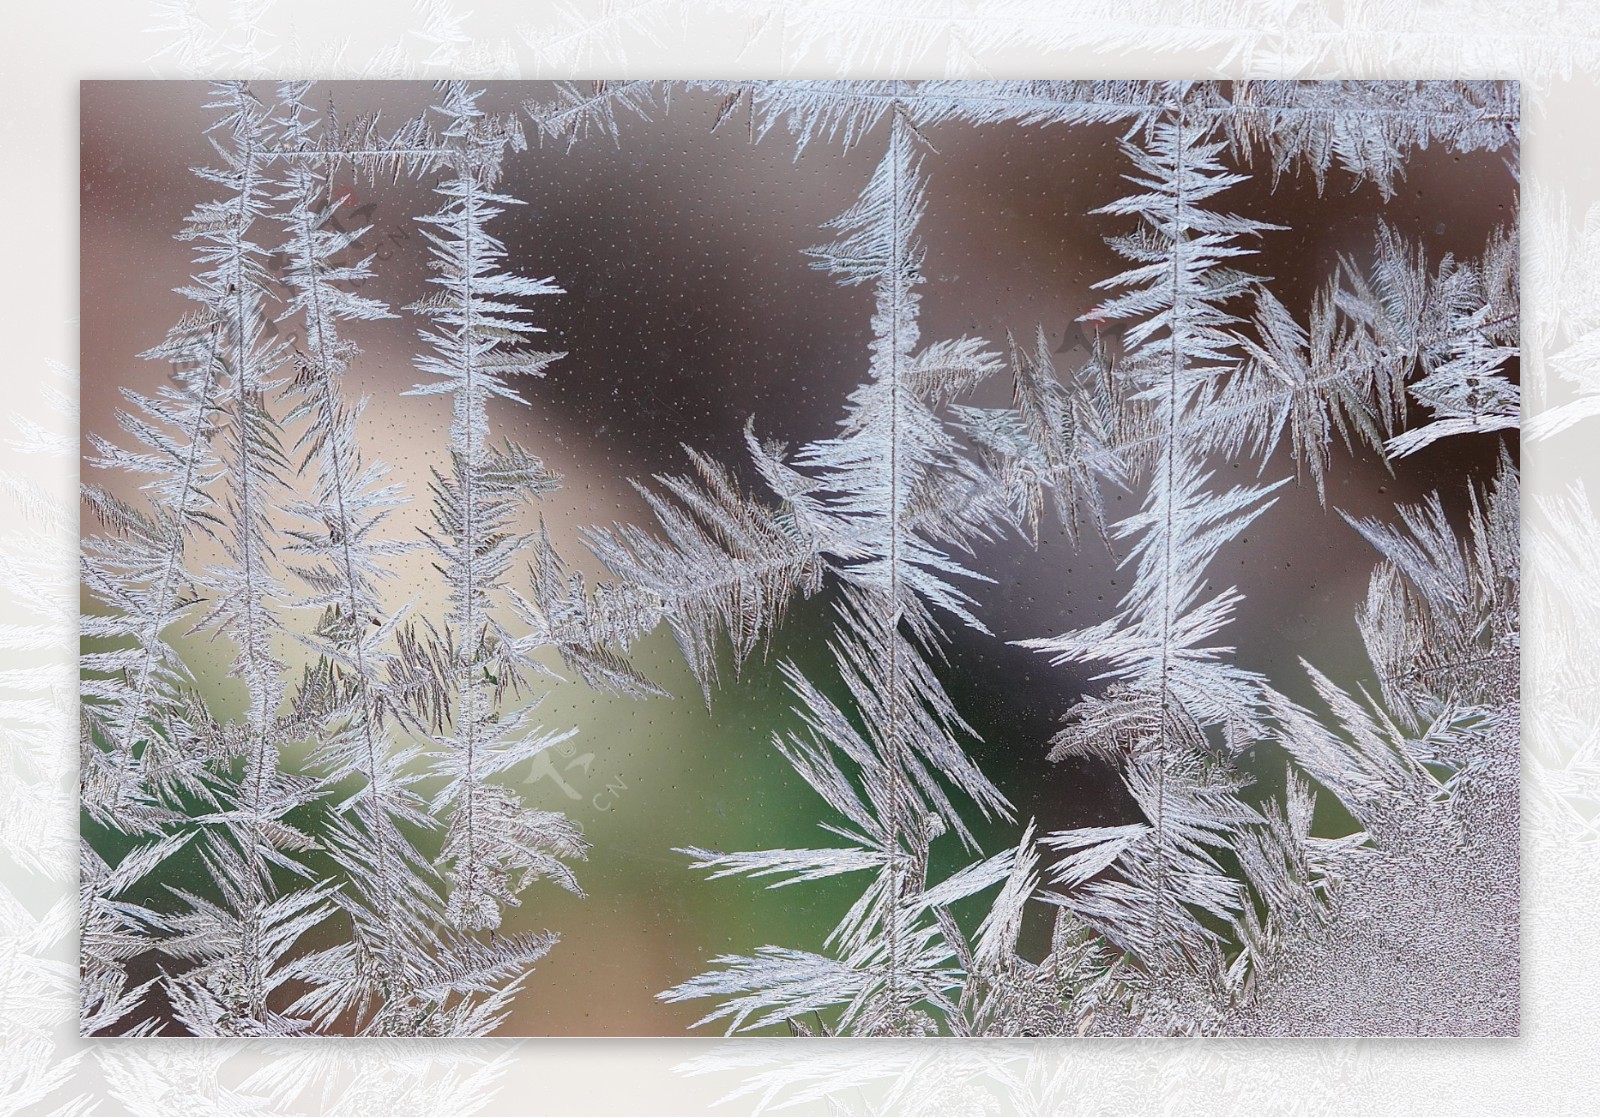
[80,82,1520,1036]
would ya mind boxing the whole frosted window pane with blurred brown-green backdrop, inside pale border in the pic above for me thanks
[82,82,1518,1035]
